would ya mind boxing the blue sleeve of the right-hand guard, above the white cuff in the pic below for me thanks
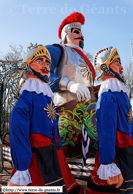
[96,95,117,164]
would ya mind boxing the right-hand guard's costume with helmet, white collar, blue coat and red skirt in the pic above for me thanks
[86,47,133,194]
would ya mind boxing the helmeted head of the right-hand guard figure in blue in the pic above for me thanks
[94,47,124,82]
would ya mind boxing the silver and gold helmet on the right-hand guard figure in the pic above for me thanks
[94,46,124,82]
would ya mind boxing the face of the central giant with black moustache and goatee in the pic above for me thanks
[71,28,84,48]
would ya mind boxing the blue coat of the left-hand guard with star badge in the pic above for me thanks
[9,90,59,170]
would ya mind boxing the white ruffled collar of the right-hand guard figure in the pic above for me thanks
[98,78,128,96]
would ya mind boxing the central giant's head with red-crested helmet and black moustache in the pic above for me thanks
[58,12,85,48]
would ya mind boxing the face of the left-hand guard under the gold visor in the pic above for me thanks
[30,56,51,77]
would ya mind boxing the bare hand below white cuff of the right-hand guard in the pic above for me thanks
[106,174,124,189]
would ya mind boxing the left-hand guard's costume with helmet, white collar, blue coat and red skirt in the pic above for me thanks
[10,46,83,194]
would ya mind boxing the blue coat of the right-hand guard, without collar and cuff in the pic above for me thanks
[96,91,133,164]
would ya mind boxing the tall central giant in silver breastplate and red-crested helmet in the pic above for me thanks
[46,12,97,179]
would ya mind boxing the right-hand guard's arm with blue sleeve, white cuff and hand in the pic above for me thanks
[96,95,123,187]
